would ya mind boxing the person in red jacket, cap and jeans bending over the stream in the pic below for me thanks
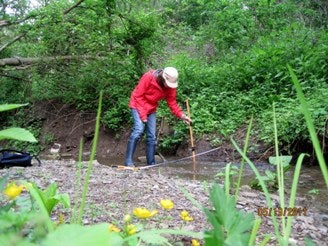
[125,67,191,166]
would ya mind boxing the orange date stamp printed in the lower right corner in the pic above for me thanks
[257,207,307,217]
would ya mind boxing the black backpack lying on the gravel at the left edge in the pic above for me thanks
[0,149,41,168]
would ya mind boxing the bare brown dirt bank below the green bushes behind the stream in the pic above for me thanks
[35,101,273,162]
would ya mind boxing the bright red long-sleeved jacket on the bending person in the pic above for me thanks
[129,70,183,121]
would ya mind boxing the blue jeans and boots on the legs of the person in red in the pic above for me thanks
[125,109,156,166]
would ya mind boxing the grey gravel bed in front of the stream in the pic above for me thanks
[0,160,328,246]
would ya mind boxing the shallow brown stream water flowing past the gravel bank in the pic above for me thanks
[98,158,328,214]
